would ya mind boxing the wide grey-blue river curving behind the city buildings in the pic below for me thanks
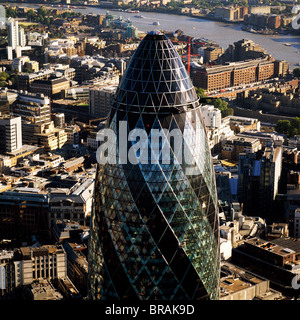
[5,3,300,69]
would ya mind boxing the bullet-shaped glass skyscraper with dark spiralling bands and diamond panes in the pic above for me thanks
[89,31,219,300]
